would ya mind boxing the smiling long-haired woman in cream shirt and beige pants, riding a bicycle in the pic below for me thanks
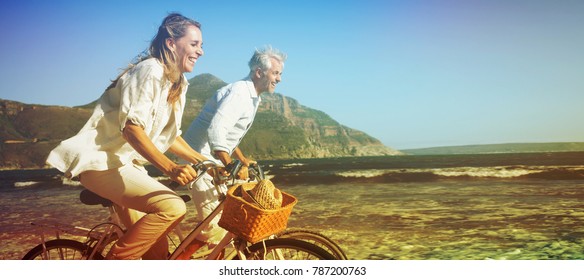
[47,14,205,259]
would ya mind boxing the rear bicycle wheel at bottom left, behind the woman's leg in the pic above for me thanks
[22,239,103,260]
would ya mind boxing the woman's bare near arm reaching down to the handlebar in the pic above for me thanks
[122,121,197,185]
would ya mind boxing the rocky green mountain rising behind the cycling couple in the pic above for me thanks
[0,74,401,168]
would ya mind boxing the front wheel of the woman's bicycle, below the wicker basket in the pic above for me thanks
[234,238,335,260]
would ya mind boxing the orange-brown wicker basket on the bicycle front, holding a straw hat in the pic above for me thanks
[219,183,298,243]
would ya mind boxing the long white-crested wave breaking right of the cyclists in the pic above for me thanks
[273,166,584,183]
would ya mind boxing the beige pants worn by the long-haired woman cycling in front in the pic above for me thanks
[79,164,186,259]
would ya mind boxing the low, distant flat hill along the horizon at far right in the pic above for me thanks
[401,142,584,155]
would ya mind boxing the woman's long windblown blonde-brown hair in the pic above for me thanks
[108,13,201,103]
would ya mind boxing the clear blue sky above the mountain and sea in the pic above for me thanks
[0,0,584,149]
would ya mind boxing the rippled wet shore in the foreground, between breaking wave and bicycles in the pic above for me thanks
[0,180,584,260]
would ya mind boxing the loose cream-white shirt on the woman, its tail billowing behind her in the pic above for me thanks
[47,58,188,177]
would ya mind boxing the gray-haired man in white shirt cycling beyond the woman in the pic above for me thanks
[181,46,287,258]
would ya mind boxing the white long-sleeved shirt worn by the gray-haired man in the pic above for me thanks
[183,79,261,163]
